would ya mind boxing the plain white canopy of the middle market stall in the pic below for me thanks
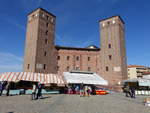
[63,72,108,85]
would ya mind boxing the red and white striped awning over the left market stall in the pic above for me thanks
[0,72,64,84]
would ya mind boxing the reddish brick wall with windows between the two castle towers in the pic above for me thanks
[58,49,99,73]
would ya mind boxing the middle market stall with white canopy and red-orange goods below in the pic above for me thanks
[63,71,108,95]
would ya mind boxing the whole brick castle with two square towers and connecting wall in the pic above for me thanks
[23,8,127,85]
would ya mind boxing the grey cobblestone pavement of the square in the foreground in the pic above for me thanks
[0,93,150,113]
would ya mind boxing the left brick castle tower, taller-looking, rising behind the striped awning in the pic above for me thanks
[23,8,57,73]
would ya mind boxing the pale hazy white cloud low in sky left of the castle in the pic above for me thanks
[0,52,23,72]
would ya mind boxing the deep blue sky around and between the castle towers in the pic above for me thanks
[0,0,150,72]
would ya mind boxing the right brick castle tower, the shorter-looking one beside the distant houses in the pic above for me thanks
[100,16,127,85]
